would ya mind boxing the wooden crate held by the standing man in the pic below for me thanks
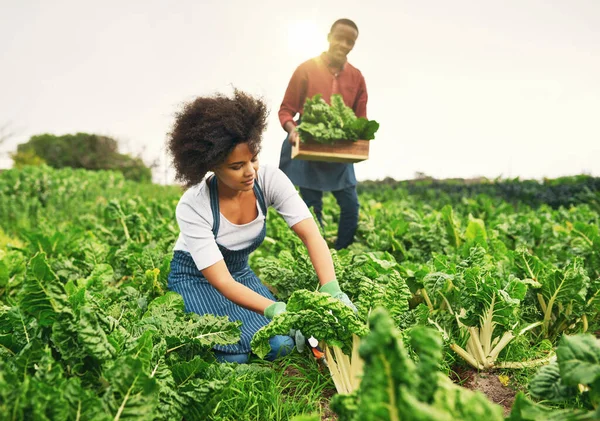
[292,140,371,164]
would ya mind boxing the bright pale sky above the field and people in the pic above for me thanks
[0,0,600,182]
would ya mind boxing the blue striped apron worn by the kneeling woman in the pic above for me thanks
[168,177,275,354]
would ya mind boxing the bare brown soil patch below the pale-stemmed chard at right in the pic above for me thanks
[450,367,517,417]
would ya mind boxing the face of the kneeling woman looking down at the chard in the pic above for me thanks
[214,143,258,192]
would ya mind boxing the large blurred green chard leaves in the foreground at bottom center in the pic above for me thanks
[332,309,502,421]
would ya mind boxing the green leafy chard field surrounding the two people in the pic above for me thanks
[0,166,600,421]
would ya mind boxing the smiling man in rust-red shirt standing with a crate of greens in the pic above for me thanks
[279,19,367,250]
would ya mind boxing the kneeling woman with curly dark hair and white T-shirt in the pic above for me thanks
[168,90,352,363]
